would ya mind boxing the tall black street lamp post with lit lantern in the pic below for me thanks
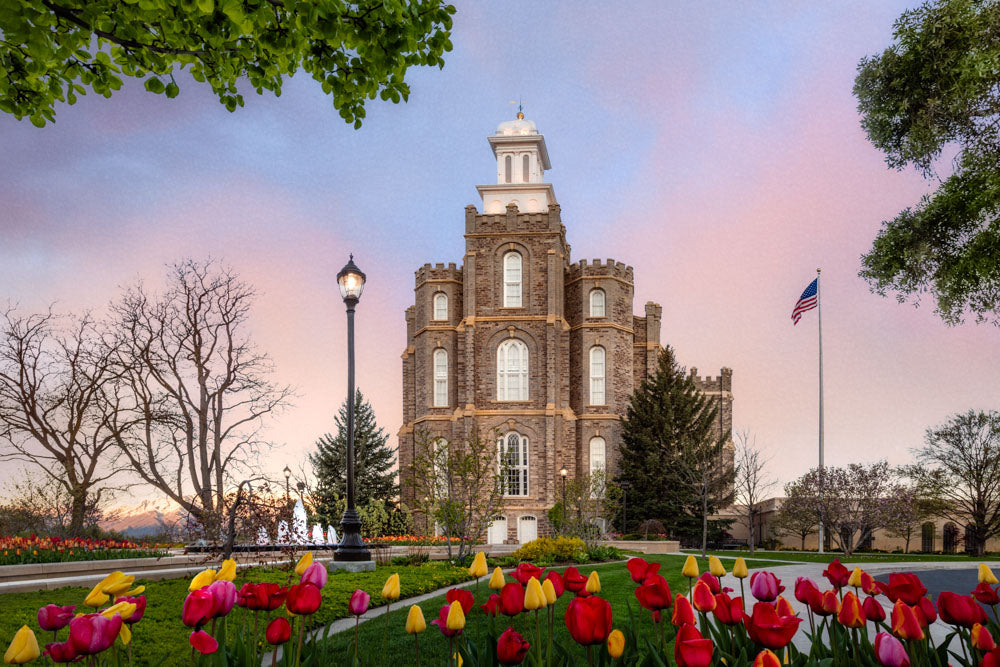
[333,255,372,562]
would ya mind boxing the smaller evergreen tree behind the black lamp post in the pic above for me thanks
[309,390,399,524]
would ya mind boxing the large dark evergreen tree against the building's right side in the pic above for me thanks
[615,346,733,538]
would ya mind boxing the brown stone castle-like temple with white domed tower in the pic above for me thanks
[399,114,733,544]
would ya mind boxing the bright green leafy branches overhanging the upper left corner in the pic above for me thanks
[0,0,455,127]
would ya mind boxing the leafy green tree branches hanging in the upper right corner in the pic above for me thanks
[854,0,1000,324]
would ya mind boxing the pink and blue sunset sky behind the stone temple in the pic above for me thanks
[0,1,1000,495]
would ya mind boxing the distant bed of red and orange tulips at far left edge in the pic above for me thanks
[0,535,167,565]
